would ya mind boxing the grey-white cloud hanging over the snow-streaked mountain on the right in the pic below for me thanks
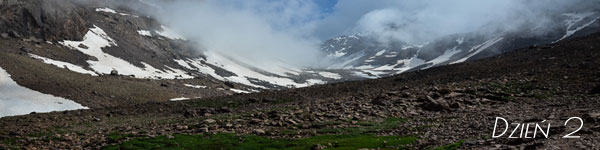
[315,0,598,43]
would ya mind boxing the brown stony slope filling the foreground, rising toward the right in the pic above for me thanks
[0,30,600,149]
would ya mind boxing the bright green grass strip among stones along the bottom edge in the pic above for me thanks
[103,134,416,150]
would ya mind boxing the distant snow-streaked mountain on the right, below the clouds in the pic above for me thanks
[321,11,600,78]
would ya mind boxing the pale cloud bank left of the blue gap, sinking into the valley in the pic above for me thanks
[144,0,322,67]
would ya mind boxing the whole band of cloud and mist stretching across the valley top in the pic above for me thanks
[129,0,599,67]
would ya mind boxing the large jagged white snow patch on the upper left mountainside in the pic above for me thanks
[60,26,193,79]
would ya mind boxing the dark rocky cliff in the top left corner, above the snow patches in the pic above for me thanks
[0,0,89,41]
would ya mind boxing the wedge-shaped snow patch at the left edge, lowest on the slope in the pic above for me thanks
[0,68,88,117]
